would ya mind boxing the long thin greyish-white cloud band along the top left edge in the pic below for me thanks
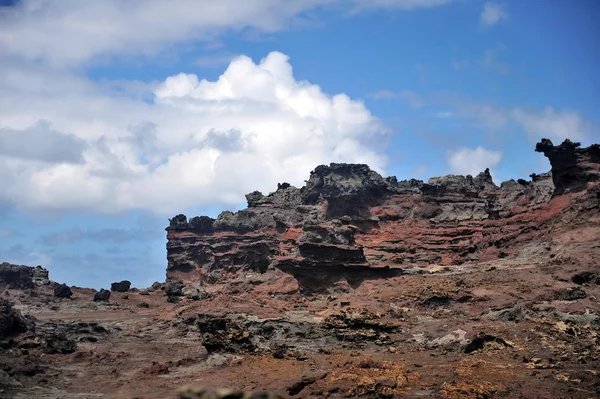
[0,0,448,65]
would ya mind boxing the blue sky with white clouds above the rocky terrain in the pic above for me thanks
[0,0,600,288]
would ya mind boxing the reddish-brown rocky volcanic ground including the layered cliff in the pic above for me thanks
[0,142,600,399]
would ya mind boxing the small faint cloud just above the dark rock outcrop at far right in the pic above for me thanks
[512,107,600,141]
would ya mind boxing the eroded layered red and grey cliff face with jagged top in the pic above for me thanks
[167,139,600,293]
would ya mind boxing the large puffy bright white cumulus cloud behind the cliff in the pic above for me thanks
[0,52,387,214]
